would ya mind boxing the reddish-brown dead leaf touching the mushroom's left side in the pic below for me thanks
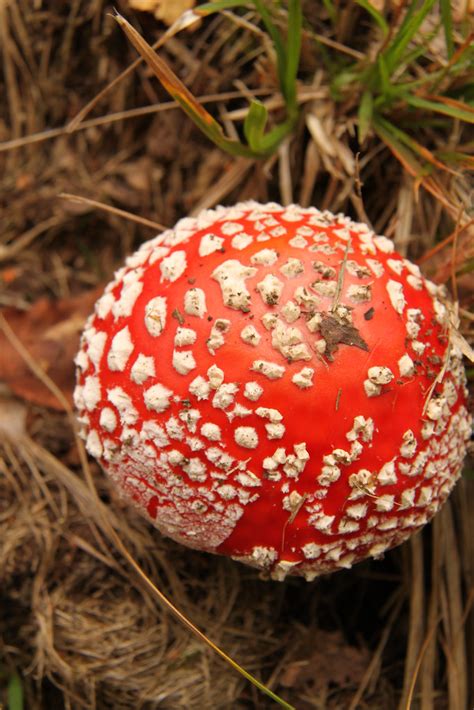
[0,287,102,410]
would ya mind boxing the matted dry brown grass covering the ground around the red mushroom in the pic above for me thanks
[0,0,474,710]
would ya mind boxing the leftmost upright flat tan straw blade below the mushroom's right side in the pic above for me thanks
[399,534,425,710]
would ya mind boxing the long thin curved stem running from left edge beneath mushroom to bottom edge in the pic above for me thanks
[0,313,295,710]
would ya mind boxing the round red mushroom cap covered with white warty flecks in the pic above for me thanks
[75,202,470,579]
